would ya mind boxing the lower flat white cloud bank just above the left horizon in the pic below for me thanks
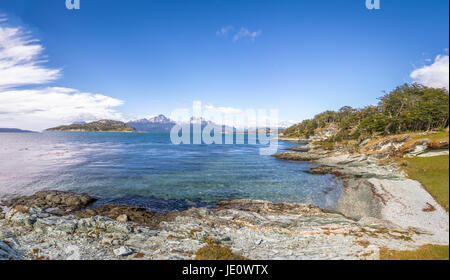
[0,87,123,130]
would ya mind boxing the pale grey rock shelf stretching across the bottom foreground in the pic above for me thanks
[0,197,436,260]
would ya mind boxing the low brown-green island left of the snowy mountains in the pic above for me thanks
[46,120,137,132]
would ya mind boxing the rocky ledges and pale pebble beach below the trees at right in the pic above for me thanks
[268,141,449,245]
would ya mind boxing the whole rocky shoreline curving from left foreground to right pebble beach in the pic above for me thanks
[0,140,449,260]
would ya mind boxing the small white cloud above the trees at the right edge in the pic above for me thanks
[410,55,449,89]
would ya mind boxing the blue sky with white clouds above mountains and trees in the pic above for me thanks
[0,0,449,130]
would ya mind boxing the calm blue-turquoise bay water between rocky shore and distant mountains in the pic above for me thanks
[0,132,341,211]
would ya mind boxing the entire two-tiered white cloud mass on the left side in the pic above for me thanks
[0,15,123,130]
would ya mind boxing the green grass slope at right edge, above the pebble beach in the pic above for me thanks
[400,155,449,211]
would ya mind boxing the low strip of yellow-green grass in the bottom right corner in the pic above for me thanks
[380,245,449,260]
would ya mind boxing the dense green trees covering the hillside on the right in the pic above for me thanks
[284,83,449,141]
